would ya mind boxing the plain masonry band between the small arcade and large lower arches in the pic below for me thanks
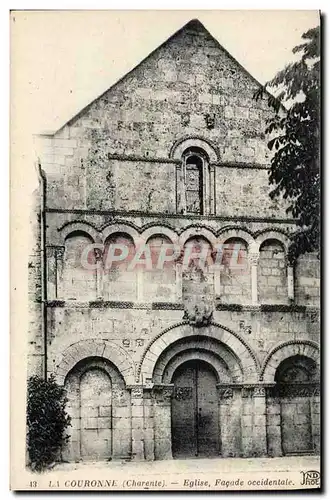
[48,303,319,378]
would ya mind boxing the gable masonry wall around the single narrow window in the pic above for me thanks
[37,19,285,217]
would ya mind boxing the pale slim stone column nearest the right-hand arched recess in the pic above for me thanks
[253,387,267,457]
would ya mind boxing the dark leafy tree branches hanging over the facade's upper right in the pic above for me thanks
[255,27,320,260]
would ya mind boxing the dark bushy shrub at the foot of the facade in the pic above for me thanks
[27,375,71,471]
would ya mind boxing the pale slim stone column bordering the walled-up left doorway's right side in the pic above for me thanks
[128,385,145,461]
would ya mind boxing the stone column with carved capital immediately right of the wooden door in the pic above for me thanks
[218,385,242,457]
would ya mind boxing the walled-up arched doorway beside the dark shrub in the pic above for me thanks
[63,356,131,461]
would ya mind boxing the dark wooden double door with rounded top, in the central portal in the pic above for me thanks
[172,360,220,458]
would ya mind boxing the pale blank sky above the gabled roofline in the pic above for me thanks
[11,10,319,133]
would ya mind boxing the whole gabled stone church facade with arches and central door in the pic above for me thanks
[28,21,320,461]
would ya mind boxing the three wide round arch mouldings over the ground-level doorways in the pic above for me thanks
[55,322,319,385]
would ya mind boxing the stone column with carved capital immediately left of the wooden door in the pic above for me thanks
[153,385,174,460]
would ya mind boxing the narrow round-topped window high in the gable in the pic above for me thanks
[183,148,207,215]
